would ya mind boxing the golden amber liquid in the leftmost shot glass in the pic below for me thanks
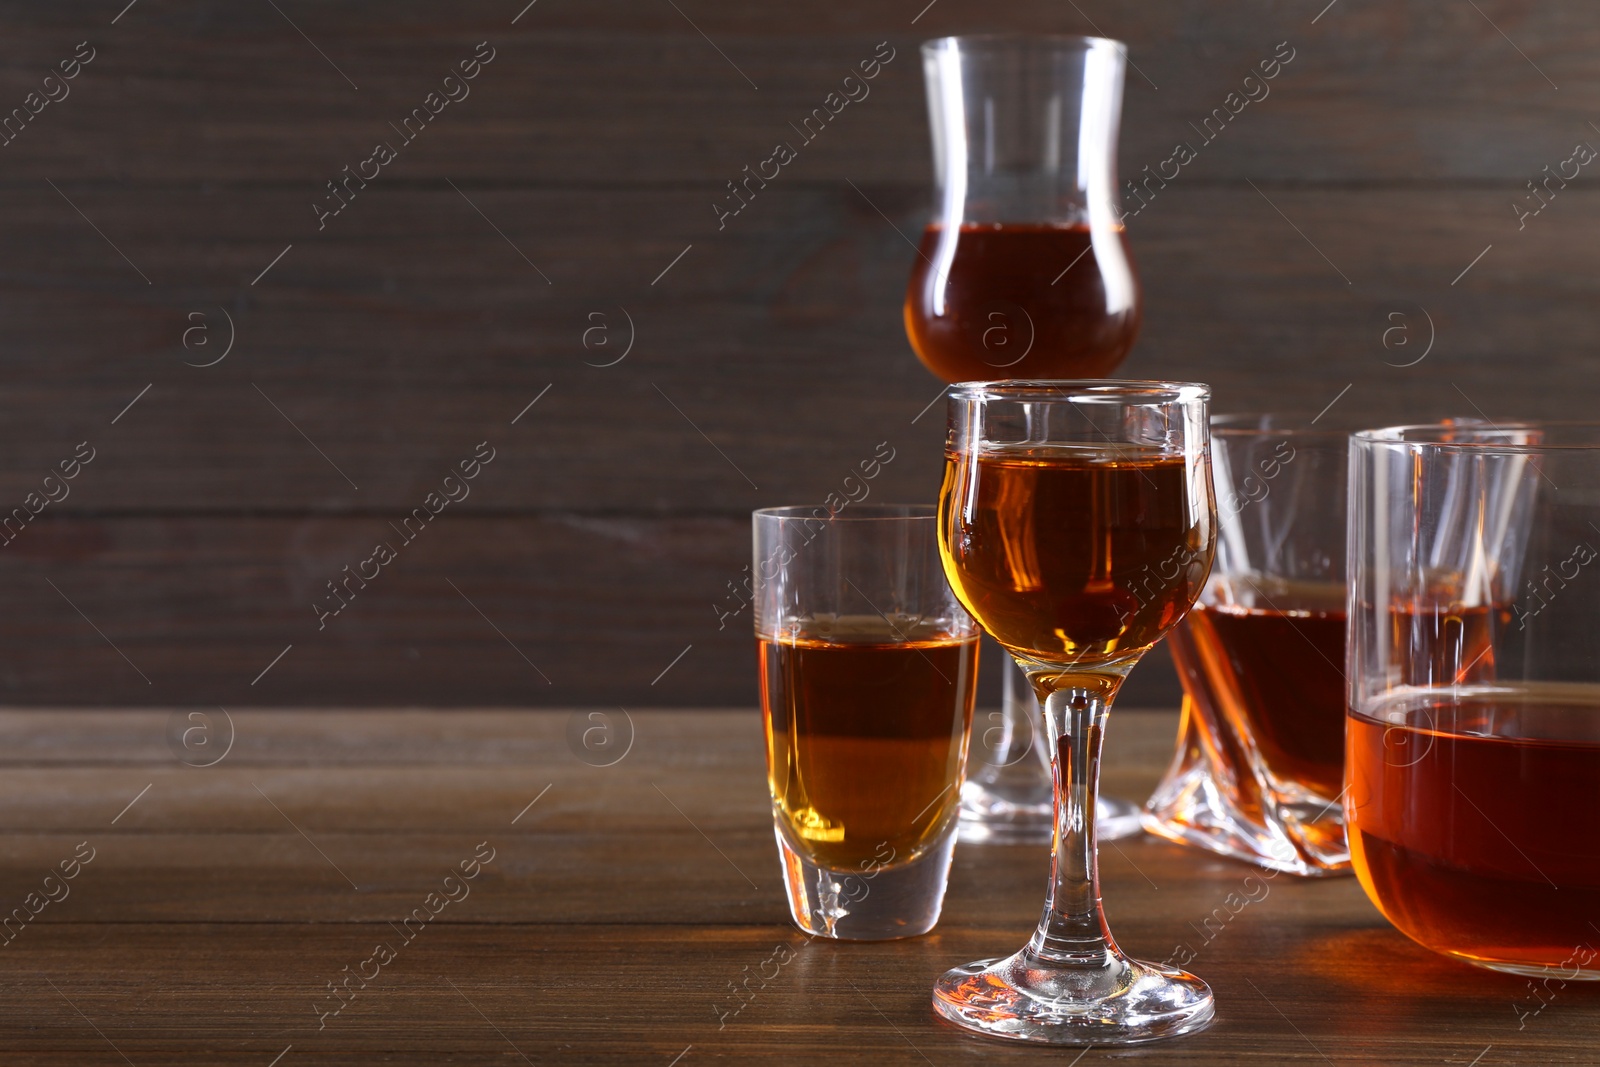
[760,617,978,872]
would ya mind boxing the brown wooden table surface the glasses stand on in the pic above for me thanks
[0,710,1600,1067]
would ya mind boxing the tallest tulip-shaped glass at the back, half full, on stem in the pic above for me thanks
[906,35,1142,841]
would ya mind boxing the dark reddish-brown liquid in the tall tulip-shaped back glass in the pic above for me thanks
[906,222,1141,382]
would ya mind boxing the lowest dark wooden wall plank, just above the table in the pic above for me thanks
[0,515,1176,709]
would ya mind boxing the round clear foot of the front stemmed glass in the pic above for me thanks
[933,949,1216,1046]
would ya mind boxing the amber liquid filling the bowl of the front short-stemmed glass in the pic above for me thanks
[939,445,1213,672]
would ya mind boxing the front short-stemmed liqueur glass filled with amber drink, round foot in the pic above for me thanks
[933,381,1216,1046]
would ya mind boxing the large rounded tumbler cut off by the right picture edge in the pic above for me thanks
[1344,422,1600,981]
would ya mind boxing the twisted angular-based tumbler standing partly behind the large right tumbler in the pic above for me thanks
[1144,414,1350,875]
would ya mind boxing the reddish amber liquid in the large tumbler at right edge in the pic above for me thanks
[1346,685,1600,971]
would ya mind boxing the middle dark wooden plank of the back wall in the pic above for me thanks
[0,181,1600,517]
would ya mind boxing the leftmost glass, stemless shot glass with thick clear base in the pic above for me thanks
[752,504,979,941]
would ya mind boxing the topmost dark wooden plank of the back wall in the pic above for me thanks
[0,0,1600,183]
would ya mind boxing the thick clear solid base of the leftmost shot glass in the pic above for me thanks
[773,827,955,941]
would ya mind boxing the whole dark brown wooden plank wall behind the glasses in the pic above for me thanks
[0,0,1600,705]
